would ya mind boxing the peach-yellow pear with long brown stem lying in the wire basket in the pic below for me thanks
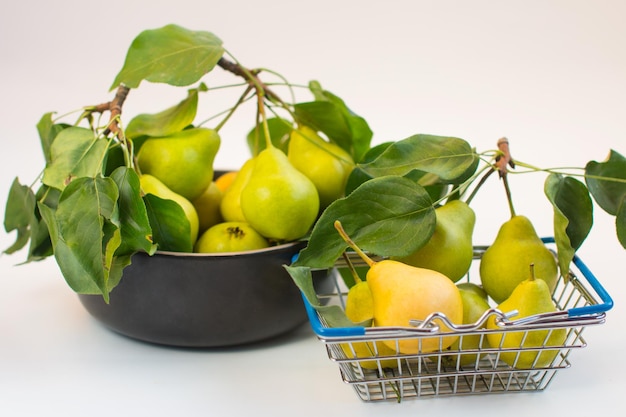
[367,260,463,354]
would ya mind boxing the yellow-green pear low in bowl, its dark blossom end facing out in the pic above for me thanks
[194,222,269,253]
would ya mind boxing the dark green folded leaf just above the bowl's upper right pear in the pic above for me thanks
[294,82,373,161]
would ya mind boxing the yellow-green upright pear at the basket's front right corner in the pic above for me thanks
[487,266,567,369]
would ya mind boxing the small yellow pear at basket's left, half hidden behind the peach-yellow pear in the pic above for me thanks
[340,281,398,369]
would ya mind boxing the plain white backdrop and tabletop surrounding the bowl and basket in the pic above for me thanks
[0,0,626,416]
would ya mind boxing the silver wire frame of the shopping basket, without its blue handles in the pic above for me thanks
[309,247,610,402]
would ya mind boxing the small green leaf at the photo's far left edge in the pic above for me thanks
[4,178,36,254]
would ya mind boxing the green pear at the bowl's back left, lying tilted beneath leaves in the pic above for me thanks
[137,128,220,201]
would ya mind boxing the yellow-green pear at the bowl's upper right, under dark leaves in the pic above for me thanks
[287,126,354,209]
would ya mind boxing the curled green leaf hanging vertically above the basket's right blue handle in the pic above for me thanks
[544,174,593,274]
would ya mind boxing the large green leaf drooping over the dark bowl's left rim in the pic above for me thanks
[39,177,120,302]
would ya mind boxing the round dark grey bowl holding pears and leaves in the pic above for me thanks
[79,242,333,348]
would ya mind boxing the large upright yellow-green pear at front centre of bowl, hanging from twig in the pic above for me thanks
[241,146,320,241]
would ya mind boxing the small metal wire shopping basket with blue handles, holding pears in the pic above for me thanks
[304,239,613,402]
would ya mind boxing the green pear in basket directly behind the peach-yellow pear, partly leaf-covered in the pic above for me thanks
[394,200,476,282]
